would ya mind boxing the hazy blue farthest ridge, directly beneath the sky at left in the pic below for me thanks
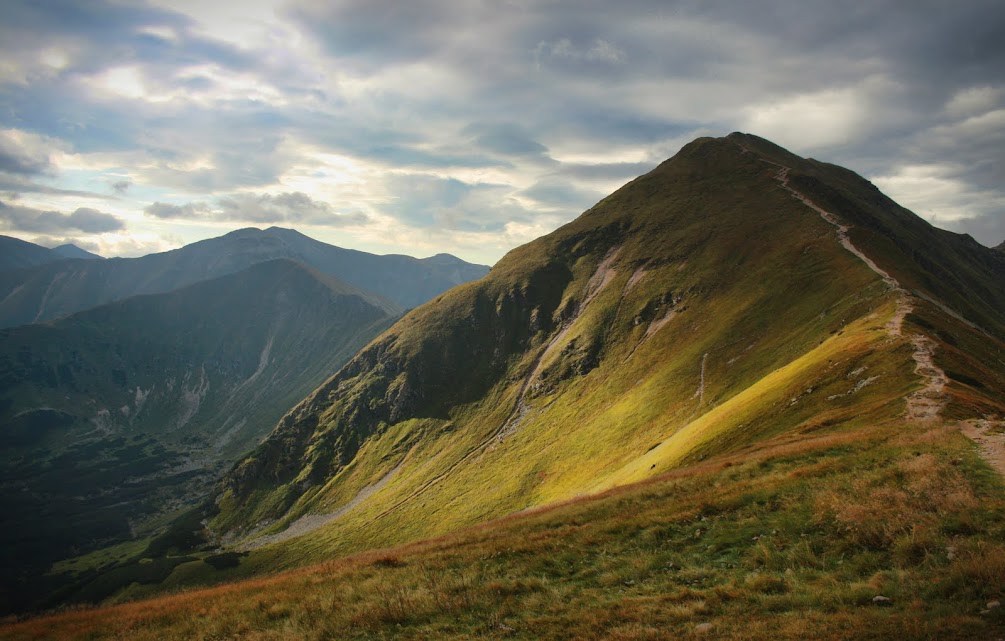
[0,227,487,327]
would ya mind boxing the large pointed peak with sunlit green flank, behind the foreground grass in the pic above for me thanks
[189,134,1005,568]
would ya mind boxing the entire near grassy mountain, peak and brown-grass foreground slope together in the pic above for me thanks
[3,134,1005,639]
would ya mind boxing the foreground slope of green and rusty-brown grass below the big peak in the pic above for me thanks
[0,413,1005,640]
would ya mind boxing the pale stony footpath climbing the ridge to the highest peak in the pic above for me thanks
[761,159,944,421]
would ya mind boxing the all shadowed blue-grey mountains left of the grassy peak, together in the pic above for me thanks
[0,228,487,609]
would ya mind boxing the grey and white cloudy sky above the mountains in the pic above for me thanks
[0,0,1005,263]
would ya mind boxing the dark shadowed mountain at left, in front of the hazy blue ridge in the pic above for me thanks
[0,260,398,610]
